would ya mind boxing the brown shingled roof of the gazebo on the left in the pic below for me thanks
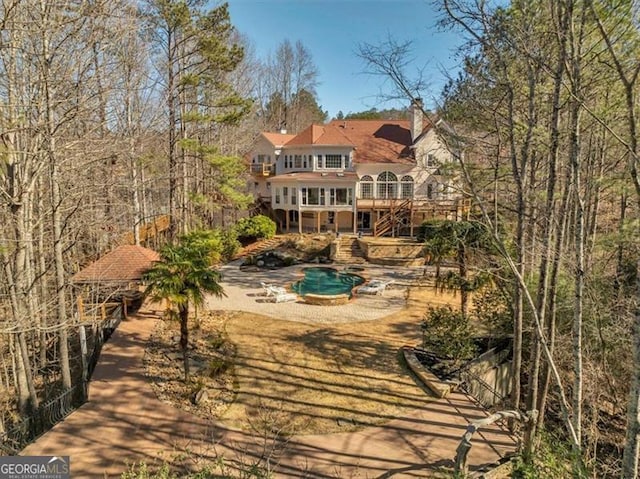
[71,245,160,283]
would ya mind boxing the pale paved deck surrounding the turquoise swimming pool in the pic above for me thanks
[206,260,424,324]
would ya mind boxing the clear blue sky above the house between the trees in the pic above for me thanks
[228,0,462,117]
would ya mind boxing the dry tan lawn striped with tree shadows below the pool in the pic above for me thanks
[214,287,456,434]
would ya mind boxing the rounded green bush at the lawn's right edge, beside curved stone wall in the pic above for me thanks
[421,306,476,361]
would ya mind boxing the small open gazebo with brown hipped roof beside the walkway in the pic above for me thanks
[71,245,160,321]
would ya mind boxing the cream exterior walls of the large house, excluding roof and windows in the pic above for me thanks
[249,124,460,234]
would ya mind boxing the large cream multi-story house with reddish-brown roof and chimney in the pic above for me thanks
[249,100,469,236]
